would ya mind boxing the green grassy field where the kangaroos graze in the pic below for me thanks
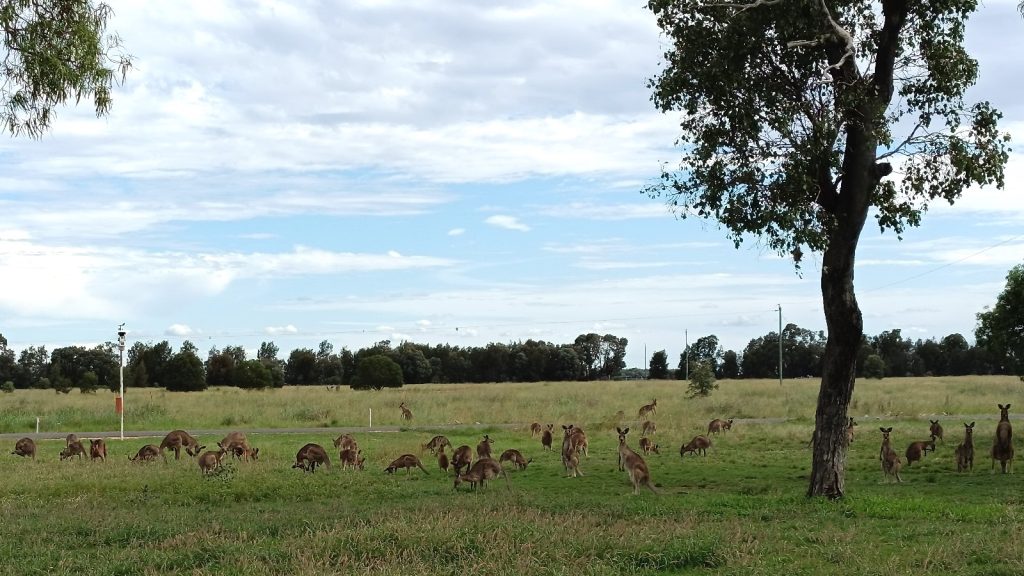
[0,378,1024,575]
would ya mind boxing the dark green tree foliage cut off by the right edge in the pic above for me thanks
[975,263,1024,380]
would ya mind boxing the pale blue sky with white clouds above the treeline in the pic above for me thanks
[0,0,1024,366]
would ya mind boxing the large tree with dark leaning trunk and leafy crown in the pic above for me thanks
[647,0,1009,497]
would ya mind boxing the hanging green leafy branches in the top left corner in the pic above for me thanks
[0,0,132,137]
